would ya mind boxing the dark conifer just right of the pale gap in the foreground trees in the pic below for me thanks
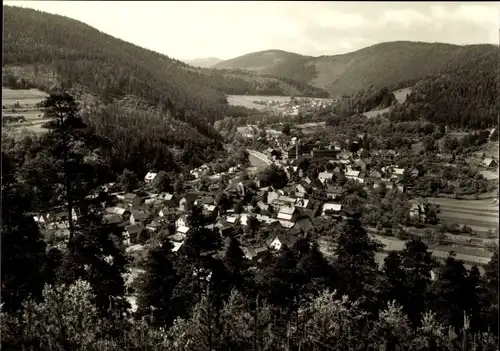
[137,239,177,326]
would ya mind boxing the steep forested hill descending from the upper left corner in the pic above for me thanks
[3,6,325,120]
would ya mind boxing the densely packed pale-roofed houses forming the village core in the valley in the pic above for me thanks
[35,132,438,259]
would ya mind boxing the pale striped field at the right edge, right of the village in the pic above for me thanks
[428,198,499,237]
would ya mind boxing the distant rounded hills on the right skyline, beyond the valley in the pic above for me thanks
[215,41,498,97]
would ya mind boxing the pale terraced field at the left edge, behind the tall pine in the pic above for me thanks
[2,88,48,133]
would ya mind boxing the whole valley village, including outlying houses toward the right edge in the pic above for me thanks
[35,122,497,268]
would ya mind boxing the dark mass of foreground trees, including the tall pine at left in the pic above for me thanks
[1,94,498,351]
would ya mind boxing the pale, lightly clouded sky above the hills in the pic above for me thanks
[4,1,500,60]
